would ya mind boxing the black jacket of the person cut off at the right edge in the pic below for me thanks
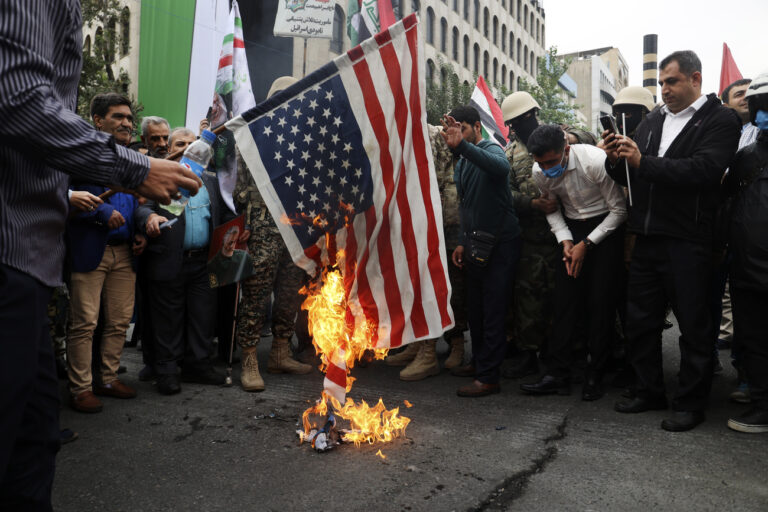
[724,132,768,293]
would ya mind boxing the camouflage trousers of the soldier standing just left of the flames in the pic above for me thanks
[237,232,306,347]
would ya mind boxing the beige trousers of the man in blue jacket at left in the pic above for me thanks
[67,244,136,396]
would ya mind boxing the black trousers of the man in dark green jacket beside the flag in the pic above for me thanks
[465,237,521,384]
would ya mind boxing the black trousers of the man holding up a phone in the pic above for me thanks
[627,235,715,411]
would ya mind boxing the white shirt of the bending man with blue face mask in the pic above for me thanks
[533,144,627,244]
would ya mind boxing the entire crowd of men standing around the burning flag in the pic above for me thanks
[0,0,768,510]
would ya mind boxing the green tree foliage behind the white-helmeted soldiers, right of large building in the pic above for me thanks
[520,46,583,128]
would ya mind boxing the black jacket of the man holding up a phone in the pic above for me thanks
[606,94,741,243]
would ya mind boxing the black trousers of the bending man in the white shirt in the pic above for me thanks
[547,215,624,378]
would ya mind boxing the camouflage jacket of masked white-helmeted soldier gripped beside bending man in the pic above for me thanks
[505,138,556,243]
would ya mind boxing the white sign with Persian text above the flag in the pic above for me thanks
[273,0,335,39]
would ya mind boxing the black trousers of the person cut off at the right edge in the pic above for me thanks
[731,286,768,410]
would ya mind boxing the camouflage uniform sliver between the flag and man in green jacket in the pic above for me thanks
[428,125,467,340]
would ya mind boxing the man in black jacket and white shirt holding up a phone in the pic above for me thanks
[603,51,741,431]
